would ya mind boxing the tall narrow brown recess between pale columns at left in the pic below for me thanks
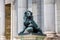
[5,4,11,40]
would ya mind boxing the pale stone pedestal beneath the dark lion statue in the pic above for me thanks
[15,35,45,40]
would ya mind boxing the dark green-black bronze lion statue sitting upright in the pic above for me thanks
[19,11,43,35]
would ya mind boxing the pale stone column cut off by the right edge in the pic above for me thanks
[56,0,60,36]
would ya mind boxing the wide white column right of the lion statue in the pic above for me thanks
[44,0,55,37]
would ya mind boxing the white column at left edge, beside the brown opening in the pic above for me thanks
[0,0,5,40]
